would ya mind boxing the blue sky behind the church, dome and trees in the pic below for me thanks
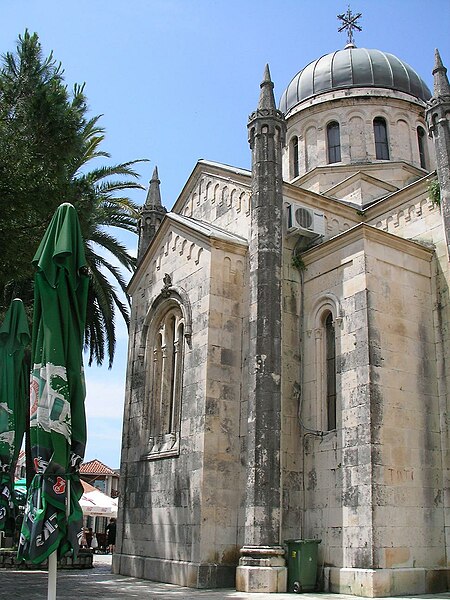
[0,0,450,467]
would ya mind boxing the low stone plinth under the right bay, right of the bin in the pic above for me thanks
[324,567,450,598]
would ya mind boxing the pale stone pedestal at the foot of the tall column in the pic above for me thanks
[236,546,287,594]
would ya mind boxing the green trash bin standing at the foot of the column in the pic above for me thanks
[284,540,322,594]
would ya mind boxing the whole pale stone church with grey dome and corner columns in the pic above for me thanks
[113,17,450,597]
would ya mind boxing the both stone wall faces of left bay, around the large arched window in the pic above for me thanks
[114,232,245,587]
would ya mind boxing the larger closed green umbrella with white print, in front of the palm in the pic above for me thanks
[19,204,88,564]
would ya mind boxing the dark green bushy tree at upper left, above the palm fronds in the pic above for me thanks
[0,32,86,287]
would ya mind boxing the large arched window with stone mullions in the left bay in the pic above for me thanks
[146,301,184,458]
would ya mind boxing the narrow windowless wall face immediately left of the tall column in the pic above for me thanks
[199,249,247,573]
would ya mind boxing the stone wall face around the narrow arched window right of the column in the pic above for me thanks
[301,227,370,566]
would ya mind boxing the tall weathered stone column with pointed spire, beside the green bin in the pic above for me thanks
[236,67,286,592]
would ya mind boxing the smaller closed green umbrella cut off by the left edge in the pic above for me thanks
[0,298,30,535]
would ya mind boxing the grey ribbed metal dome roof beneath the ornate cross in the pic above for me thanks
[280,46,431,113]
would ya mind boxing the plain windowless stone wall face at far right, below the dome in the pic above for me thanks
[367,237,445,568]
